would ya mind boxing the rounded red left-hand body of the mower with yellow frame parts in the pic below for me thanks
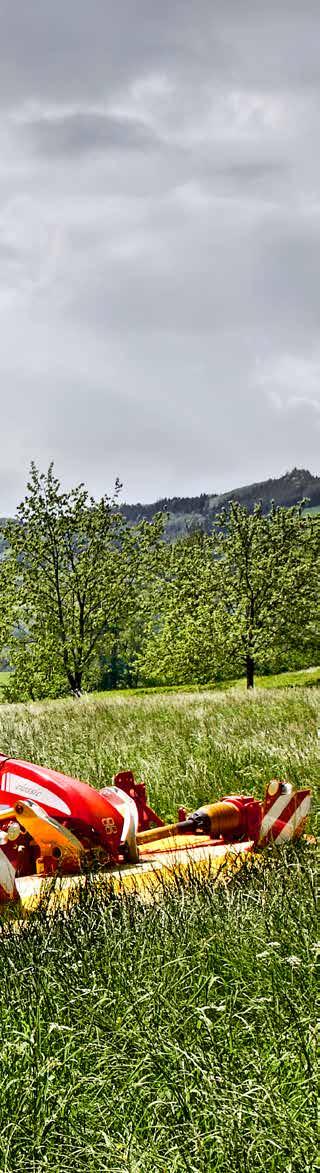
[0,754,162,903]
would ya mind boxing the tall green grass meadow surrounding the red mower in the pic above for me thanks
[0,689,320,1173]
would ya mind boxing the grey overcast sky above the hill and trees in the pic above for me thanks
[0,0,320,515]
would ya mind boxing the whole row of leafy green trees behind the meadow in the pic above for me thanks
[0,465,320,700]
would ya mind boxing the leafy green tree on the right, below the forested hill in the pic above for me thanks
[141,503,320,686]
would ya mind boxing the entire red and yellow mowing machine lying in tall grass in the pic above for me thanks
[0,754,311,907]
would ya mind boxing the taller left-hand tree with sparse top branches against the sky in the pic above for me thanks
[5,465,161,696]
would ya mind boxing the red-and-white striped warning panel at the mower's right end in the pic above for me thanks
[259,779,311,846]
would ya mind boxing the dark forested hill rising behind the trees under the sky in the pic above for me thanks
[121,468,320,537]
